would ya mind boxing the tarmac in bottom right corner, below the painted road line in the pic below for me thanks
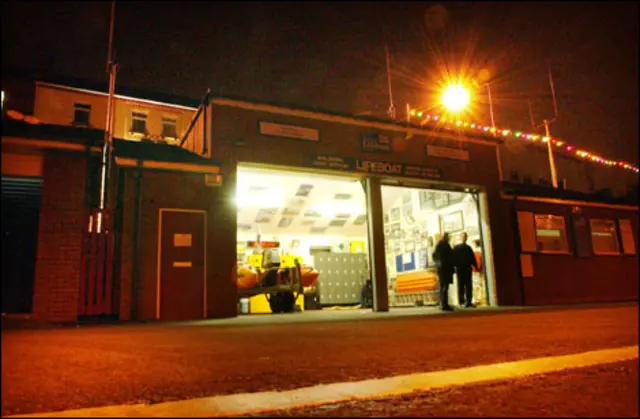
[258,361,638,418]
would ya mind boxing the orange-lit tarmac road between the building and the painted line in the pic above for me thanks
[2,304,638,416]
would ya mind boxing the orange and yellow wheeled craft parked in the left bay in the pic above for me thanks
[238,249,318,313]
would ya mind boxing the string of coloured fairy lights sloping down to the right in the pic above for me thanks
[409,109,639,173]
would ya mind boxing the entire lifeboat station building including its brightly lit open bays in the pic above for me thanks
[2,76,638,321]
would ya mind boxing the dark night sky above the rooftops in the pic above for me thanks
[2,1,639,165]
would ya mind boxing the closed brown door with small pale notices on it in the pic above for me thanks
[158,210,205,320]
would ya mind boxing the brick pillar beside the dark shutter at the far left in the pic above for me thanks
[33,152,88,321]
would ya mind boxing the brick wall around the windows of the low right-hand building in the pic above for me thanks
[494,200,638,305]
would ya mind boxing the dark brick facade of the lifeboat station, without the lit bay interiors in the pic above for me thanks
[2,80,638,321]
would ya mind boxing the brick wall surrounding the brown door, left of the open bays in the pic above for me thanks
[118,169,237,320]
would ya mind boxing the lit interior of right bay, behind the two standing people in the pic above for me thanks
[382,186,487,307]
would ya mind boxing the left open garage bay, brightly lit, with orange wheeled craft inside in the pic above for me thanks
[236,166,372,313]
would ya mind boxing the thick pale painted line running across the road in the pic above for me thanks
[7,345,638,418]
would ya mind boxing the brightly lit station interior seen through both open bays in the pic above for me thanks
[235,166,487,313]
